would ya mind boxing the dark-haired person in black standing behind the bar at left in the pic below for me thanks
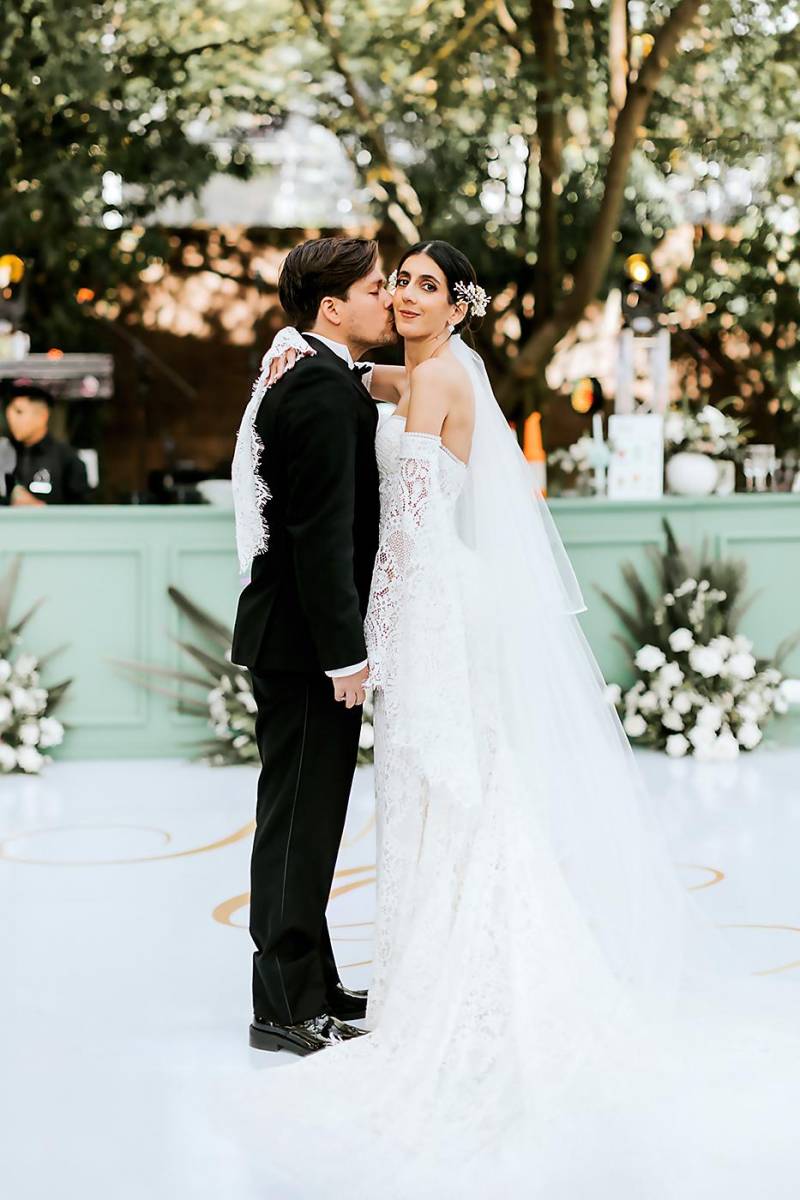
[2,383,89,508]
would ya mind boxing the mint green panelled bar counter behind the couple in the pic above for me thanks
[0,494,800,758]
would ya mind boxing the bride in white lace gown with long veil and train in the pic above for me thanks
[224,241,800,1200]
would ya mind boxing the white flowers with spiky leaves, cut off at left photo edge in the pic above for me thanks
[0,556,72,775]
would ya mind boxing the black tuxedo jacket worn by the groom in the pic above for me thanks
[231,335,379,674]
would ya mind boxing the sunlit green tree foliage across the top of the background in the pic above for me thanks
[0,0,800,440]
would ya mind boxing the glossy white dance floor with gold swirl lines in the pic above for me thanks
[0,745,800,1200]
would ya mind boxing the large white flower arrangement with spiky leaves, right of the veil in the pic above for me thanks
[603,522,800,761]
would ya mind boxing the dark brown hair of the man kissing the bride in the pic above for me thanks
[278,238,378,330]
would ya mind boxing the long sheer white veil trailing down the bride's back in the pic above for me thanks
[450,337,798,1028]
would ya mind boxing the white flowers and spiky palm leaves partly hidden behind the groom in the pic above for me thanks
[116,587,372,767]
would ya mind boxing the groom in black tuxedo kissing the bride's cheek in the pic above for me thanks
[231,238,396,1055]
